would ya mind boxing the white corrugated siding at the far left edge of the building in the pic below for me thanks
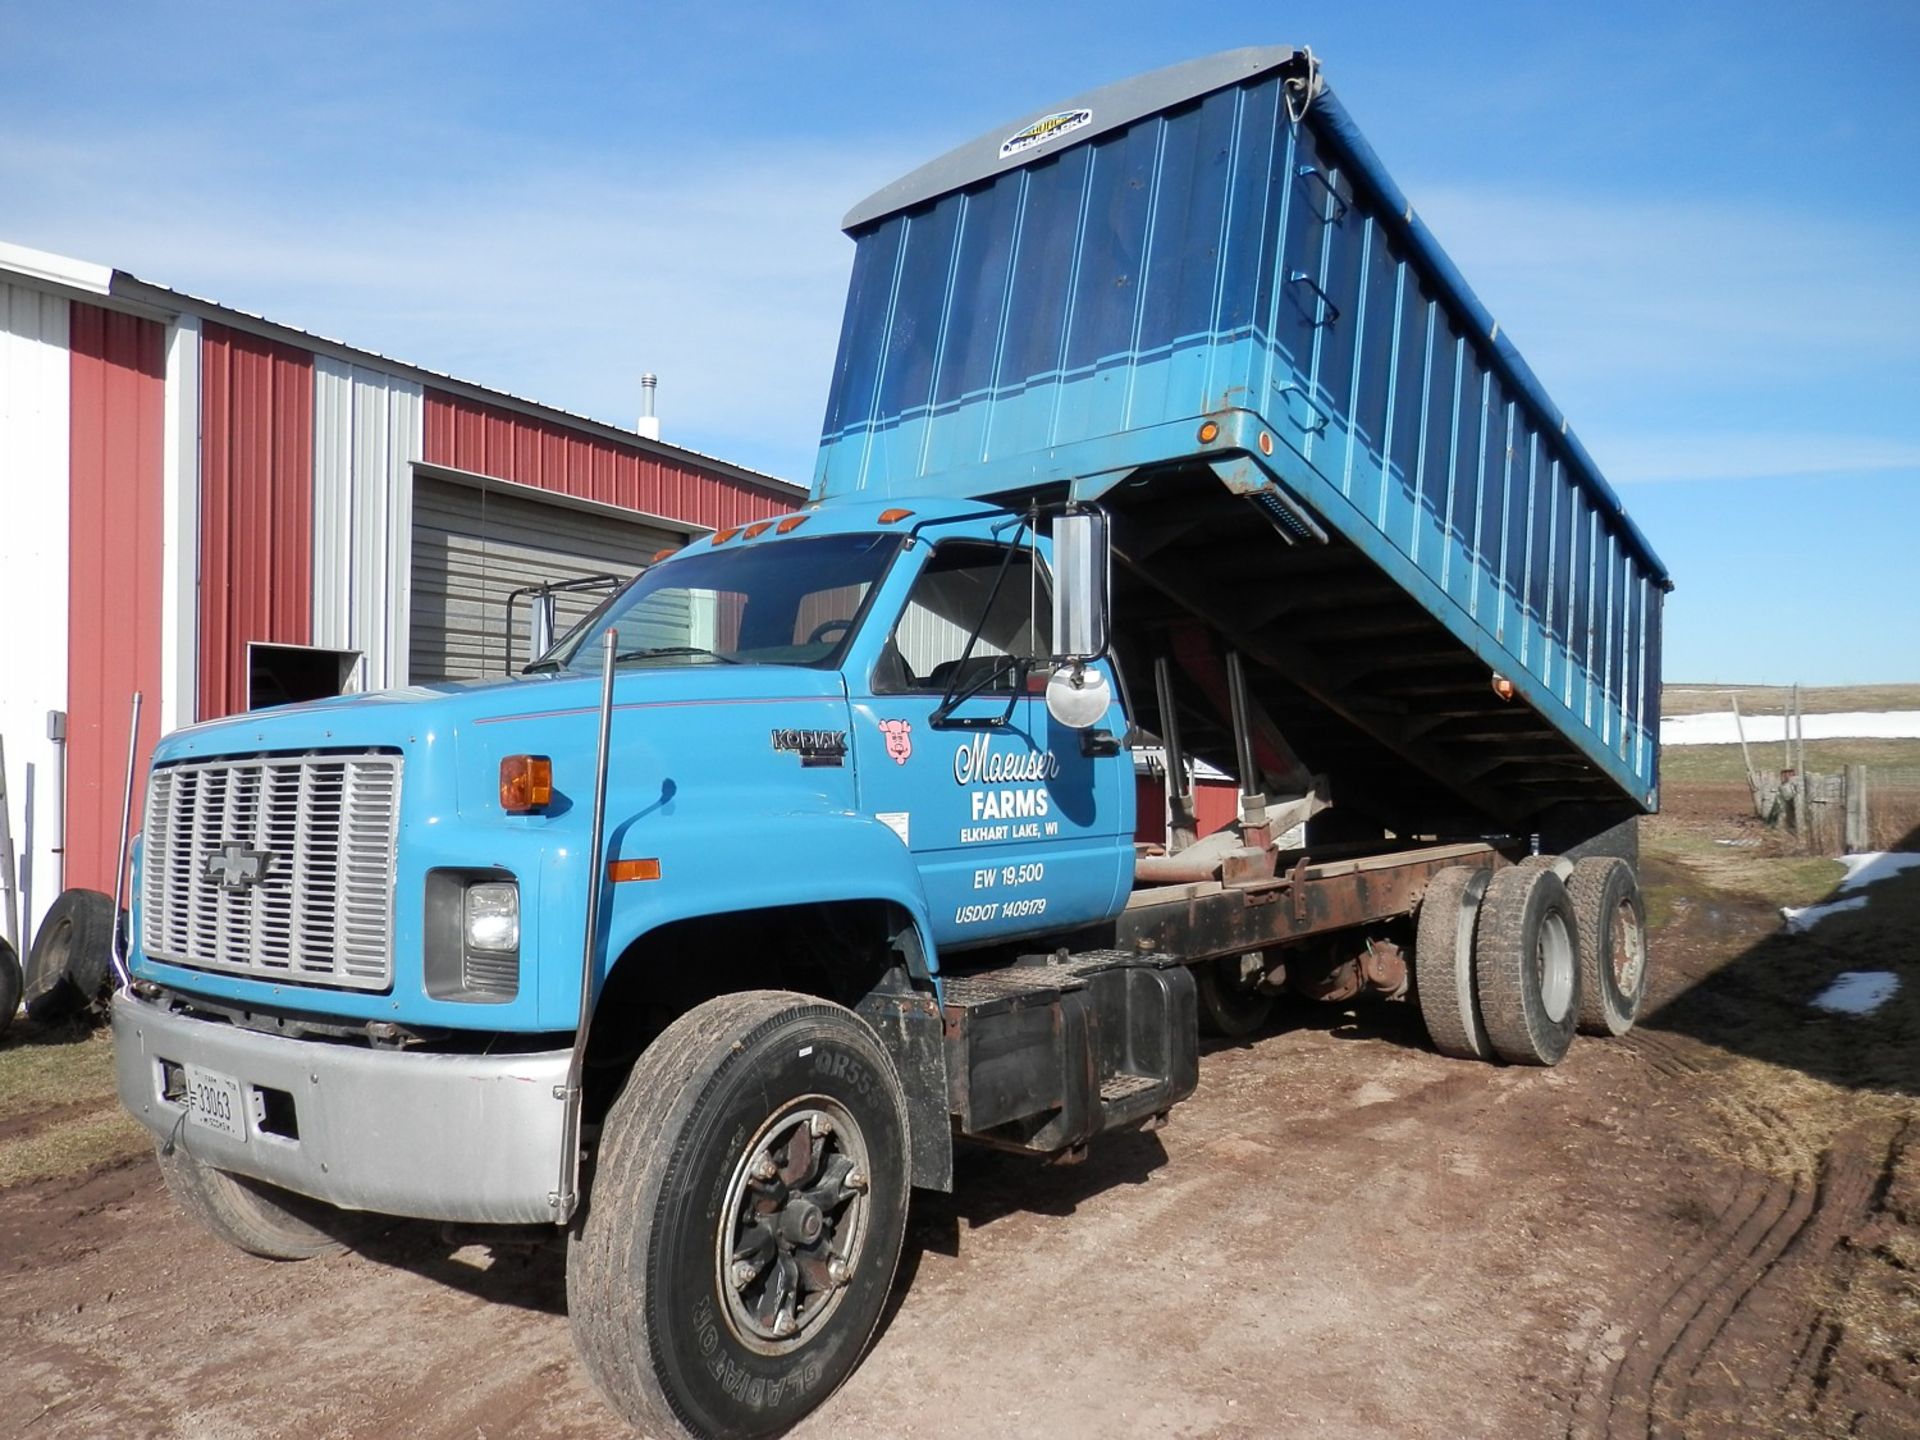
[0,284,71,927]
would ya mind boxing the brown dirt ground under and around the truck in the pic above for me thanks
[0,787,1920,1440]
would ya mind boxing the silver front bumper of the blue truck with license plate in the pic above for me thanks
[113,991,568,1225]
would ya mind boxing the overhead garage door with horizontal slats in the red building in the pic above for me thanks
[409,474,685,682]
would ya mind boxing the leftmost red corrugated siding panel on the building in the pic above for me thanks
[67,303,167,893]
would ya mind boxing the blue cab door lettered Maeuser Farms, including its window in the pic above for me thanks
[851,540,1133,948]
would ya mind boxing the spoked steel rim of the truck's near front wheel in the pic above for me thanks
[714,1094,874,1356]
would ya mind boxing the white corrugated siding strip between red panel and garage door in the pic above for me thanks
[313,366,422,689]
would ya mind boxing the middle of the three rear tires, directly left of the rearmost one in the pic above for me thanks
[1473,866,1580,1066]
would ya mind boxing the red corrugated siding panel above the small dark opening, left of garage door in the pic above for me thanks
[200,324,313,720]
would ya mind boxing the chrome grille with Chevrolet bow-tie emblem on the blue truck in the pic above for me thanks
[140,755,399,991]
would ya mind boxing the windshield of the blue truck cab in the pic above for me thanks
[528,534,900,670]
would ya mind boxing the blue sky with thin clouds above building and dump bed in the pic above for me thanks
[0,0,1920,684]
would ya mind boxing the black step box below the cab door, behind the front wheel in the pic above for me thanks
[941,950,1200,1154]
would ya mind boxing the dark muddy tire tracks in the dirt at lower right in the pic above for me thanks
[1567,1031,1887,1440]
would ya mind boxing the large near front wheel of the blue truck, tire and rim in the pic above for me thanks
[566,991,908,1436]
